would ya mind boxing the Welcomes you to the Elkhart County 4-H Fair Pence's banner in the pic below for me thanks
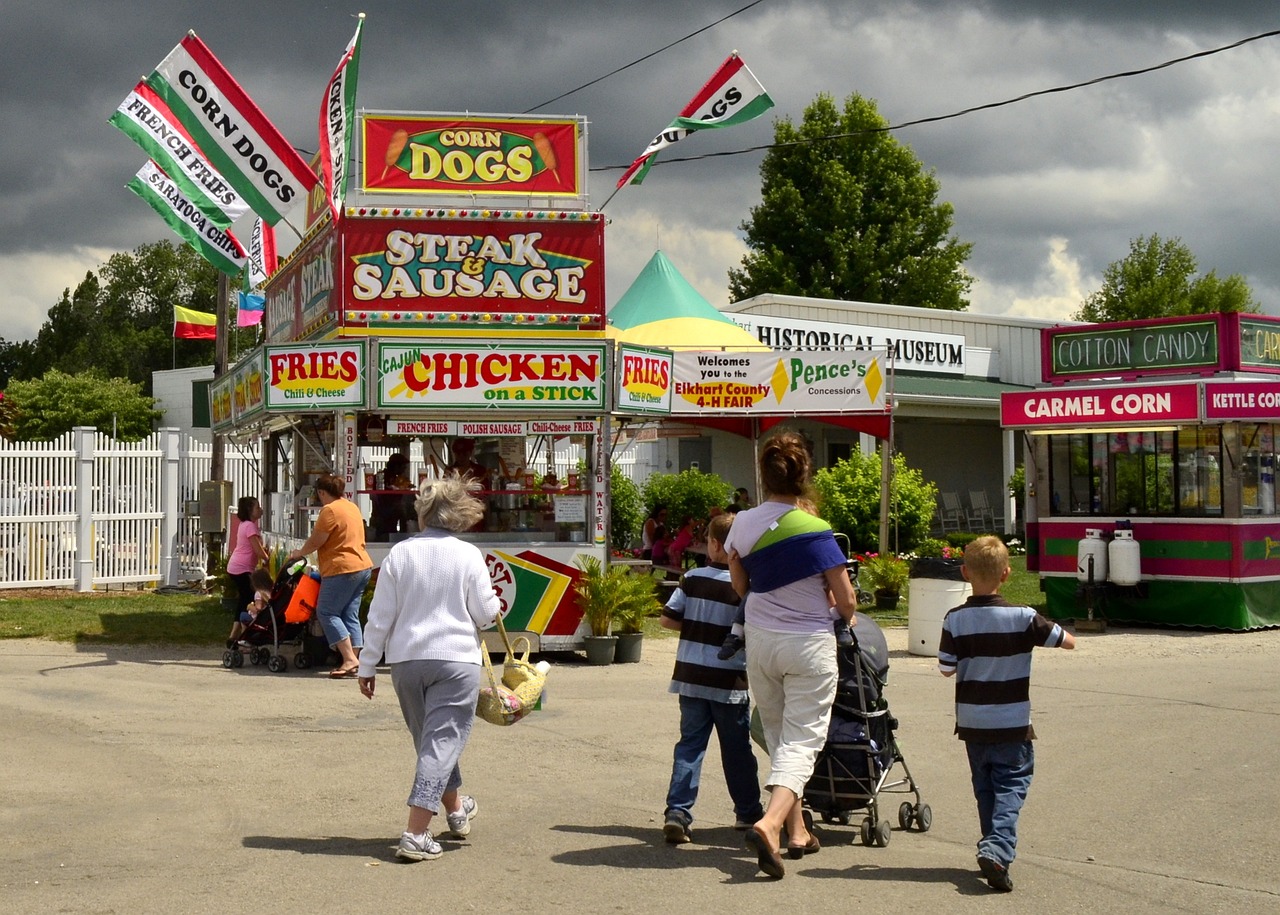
[671,351,886,416]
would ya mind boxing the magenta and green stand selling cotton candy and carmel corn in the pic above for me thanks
[1001,314,1280,630]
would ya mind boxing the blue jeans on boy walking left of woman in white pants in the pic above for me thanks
[667,696,764,825]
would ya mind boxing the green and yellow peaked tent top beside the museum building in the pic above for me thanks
[609,251,765,349]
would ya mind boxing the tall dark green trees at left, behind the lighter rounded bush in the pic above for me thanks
[11,242,256,393]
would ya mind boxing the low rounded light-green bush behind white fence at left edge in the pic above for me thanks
[4,369,161,442]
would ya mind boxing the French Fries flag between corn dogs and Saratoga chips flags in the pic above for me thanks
[109,83,248,229]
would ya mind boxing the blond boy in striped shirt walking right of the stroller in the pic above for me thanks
[938,536,1075,893]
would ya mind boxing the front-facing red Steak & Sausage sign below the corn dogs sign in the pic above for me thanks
[343,212,604,331]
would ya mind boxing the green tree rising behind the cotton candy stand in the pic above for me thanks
[1074,234,1261,322]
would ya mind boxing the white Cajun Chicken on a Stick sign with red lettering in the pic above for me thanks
[376,342,605,413]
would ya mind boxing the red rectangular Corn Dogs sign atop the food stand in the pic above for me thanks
[361,114,585,197]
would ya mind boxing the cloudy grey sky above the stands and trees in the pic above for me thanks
[0,0,1280,340]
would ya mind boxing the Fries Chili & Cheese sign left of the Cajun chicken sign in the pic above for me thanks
[266,343,365,411]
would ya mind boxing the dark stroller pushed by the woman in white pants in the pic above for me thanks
[804,613,933,848]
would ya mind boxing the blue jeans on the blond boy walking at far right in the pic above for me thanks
[965,740,1036,868]
